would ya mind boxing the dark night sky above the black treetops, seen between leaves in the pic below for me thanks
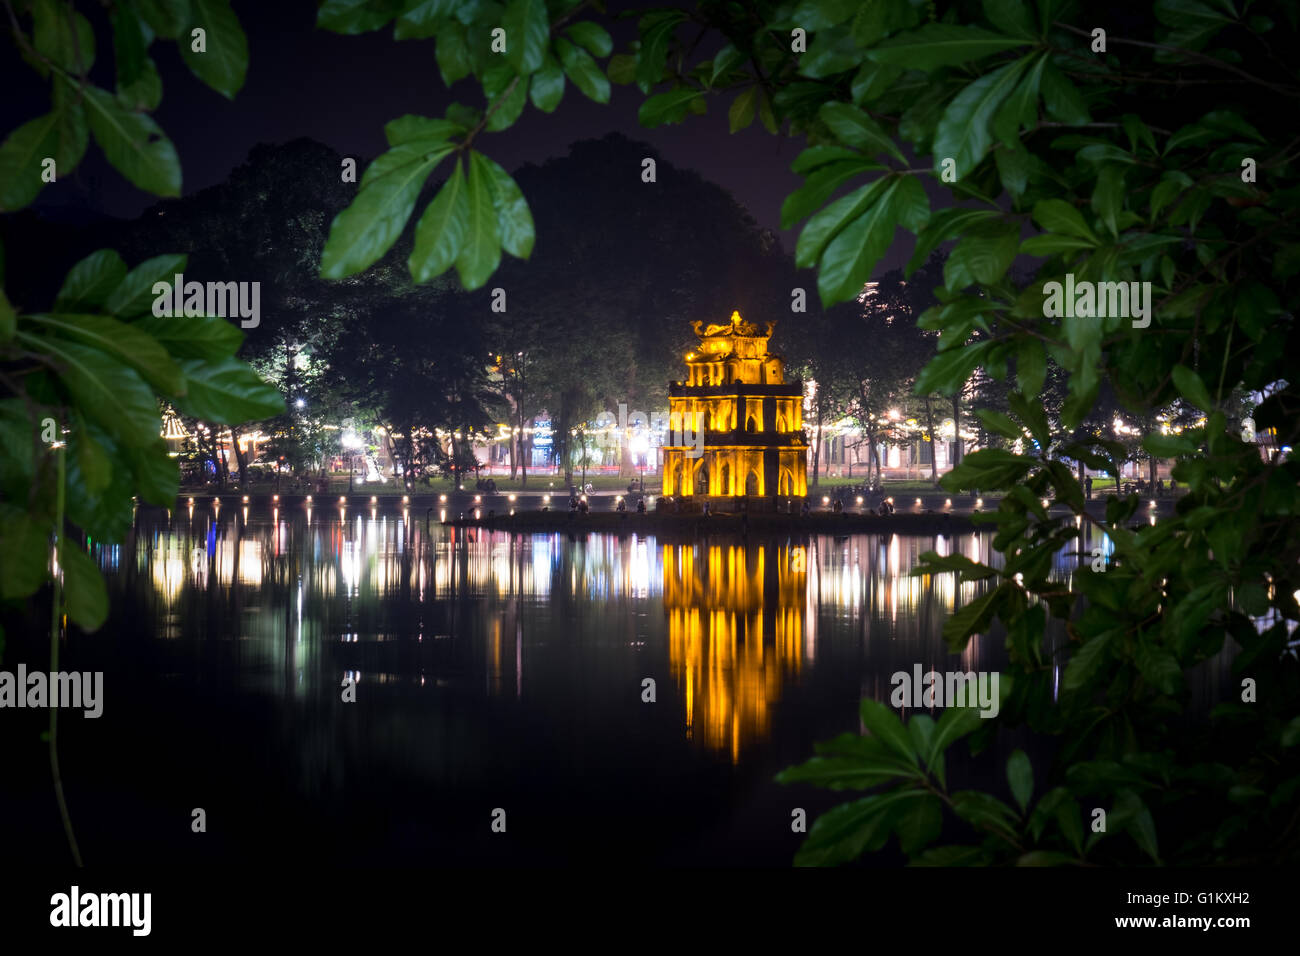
[0,0,821,251]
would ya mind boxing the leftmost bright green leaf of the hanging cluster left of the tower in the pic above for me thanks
[321,143,452,278]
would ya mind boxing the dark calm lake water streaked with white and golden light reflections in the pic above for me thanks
[0,505,1206,866]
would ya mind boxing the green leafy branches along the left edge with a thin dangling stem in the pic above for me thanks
[0,0,283,865]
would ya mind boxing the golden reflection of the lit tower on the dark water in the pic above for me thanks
[663,544,807,762]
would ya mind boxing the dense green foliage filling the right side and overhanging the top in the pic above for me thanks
[317,0,1300,864]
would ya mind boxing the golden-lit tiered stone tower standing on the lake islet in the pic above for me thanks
[663,312,807,510]
